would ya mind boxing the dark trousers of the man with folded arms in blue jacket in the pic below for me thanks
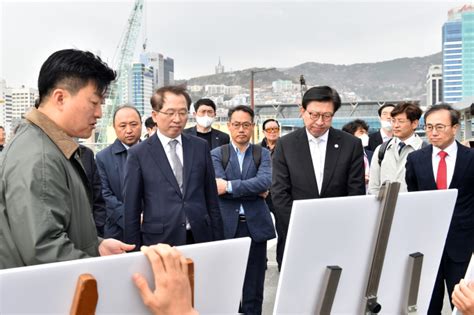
[235,218,267,314]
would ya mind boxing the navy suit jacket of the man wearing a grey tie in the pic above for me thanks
[124,134,224,249]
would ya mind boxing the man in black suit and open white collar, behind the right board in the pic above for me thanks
[271,86,365,266]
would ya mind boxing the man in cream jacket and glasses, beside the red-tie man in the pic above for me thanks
[368,103,423,195]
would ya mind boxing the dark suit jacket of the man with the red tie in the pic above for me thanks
[406,142,474,262]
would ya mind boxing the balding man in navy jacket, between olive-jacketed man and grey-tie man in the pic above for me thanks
[96,105,142,240]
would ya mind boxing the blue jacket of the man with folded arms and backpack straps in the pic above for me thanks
[211,144,275,242]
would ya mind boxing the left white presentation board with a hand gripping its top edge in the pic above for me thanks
[0,237,250,315]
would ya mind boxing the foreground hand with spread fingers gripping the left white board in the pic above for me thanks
[133,244,198,315]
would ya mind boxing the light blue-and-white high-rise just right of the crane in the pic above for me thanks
[129,63,154,118]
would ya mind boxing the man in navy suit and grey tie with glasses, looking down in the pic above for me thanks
[124,86,223,248]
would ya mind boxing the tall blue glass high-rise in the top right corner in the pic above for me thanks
[443,5,474,103]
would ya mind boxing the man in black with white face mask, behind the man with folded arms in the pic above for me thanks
[183,98,230,150]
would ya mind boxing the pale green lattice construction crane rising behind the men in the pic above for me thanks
[97,0,144,147]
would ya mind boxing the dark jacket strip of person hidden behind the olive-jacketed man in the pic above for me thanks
[79,145,106,237]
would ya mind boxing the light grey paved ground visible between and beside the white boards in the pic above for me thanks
[263,240,451,315]
